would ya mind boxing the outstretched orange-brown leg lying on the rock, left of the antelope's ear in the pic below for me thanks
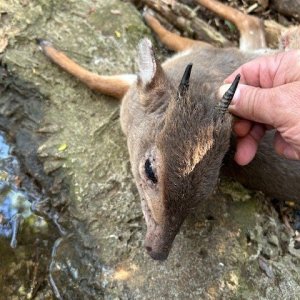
[37,39,136,99]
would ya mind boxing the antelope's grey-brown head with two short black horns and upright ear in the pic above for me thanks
[121,39,238,260]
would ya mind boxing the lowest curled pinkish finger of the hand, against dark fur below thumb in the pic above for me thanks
[234,124,265,166]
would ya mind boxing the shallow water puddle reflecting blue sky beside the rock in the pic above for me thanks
[0,131,54,299]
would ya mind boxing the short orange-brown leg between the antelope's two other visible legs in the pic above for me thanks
[144,11,212,51]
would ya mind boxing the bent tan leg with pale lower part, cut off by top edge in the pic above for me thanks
[197,0,266,50]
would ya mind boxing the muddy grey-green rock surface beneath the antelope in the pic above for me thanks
[0,0,300,299]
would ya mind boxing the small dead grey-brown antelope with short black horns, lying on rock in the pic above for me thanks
[38,0,300,260]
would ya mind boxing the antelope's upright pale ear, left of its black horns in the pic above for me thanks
[138,38,163,88]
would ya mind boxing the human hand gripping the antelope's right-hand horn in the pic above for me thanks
[220,50,300,165]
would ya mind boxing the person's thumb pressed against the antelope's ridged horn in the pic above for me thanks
[219,84,277,125]
